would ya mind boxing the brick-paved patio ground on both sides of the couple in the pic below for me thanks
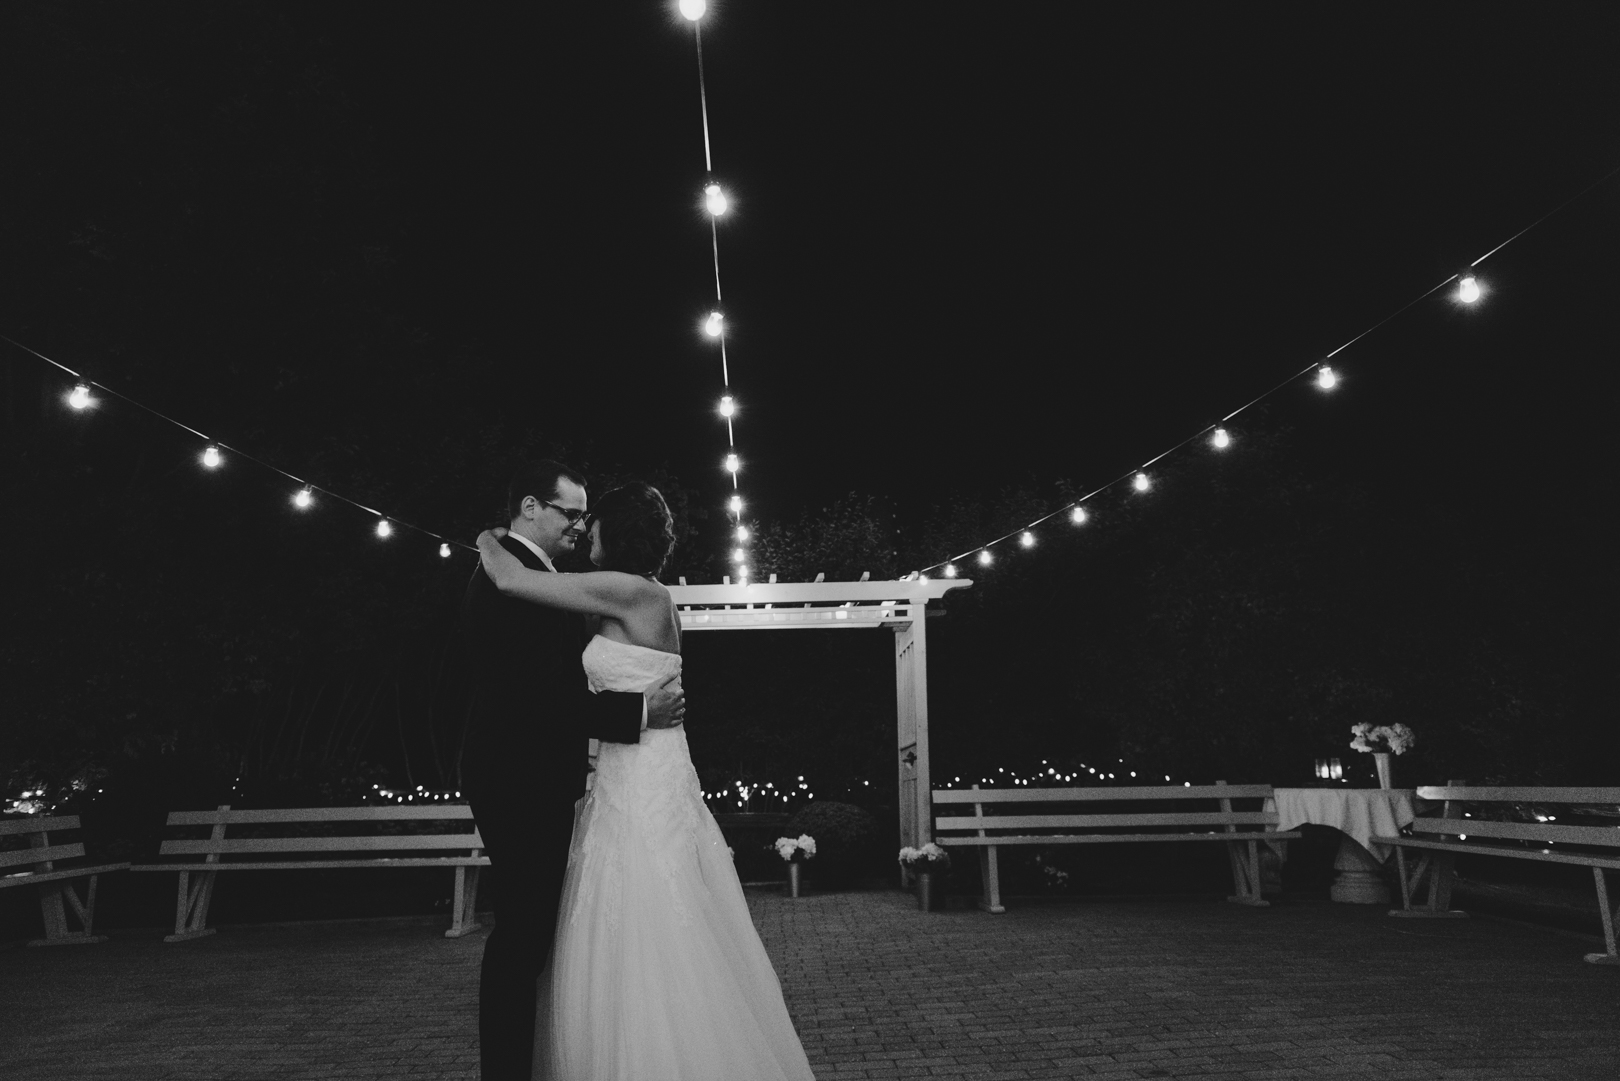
[0,891,1620,1081]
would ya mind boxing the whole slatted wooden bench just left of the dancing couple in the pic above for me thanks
[131,804,489,942]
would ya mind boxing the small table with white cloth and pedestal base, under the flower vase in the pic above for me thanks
[1265,788,1418,904]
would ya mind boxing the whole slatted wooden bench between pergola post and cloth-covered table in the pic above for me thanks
[933,781,1299,912]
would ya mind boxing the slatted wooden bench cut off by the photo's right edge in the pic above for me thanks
[1372,781,1620,964]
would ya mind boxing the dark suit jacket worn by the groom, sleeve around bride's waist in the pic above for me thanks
[462,536,642,802]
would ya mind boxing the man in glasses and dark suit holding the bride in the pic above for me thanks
[462,462,685,1081]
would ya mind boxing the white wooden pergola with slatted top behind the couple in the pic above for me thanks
[669,575,972,846]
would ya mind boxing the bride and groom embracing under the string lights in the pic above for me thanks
[463,462,812,1081]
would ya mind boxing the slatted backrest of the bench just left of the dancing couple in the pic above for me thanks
[159,804,484,861]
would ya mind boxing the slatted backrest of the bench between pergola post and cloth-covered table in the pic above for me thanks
[933,784,1277,835]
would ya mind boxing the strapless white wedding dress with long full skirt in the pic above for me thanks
[535,635,813,1081]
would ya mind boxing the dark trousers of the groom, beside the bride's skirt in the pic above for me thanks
[468,784,573,1081]
